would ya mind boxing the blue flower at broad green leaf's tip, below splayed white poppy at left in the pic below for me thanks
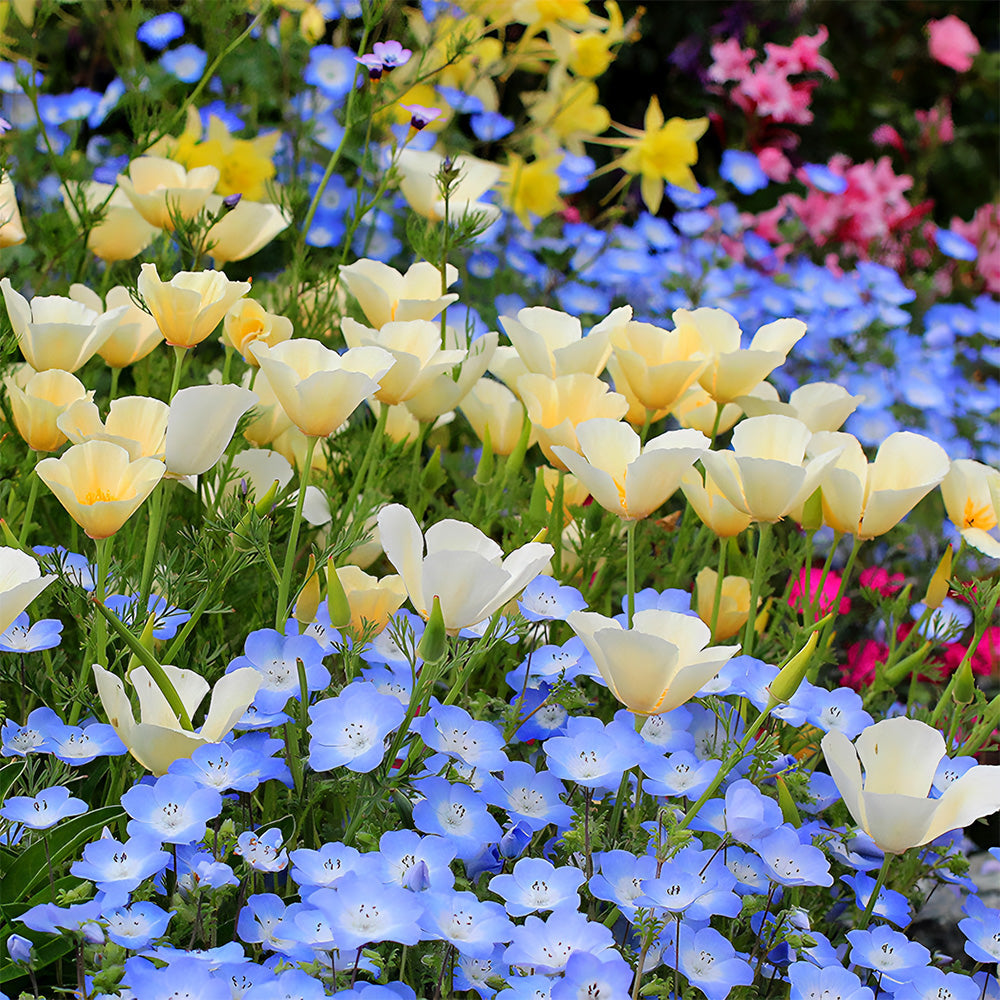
[122,774,222,844]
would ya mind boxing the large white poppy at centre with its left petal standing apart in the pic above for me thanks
[378,504,553,635]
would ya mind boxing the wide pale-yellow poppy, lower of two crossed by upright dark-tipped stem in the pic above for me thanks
[340,258,458,329]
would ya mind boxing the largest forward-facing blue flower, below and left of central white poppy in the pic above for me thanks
[308,681,406,773]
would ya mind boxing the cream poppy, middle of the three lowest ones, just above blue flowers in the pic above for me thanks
[566,609,740,715]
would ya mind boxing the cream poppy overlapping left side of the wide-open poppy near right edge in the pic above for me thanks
[702,416,840,522]
